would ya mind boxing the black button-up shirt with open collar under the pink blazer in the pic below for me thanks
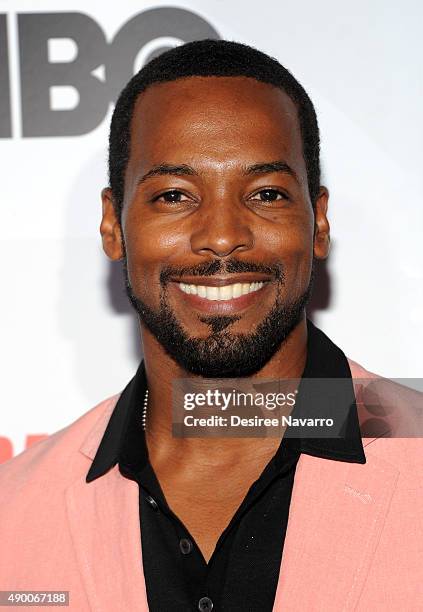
[86,321,366,612]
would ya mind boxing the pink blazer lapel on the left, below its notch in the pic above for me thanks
[66,466,148,612]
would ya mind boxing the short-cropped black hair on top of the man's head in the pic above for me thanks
[109,39,320,221]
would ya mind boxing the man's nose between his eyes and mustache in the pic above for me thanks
[191,200,254,257]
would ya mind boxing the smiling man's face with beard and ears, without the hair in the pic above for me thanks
[102,77,327,377]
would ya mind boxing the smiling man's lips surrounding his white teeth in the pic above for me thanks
[172,275,271,315]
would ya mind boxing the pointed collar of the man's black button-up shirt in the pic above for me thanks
[86,320,366,482]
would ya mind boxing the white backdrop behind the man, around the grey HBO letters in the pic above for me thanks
[0,0,423,460]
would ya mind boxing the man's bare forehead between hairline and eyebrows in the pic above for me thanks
[128,77,305,175]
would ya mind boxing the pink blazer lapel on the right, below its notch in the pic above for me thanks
[273,440,399,612]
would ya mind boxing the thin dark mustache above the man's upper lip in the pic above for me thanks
[160,259,285,287]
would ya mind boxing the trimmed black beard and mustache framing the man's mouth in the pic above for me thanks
[123,255,314,378]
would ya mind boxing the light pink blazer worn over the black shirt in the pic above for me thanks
[0,362,423,612]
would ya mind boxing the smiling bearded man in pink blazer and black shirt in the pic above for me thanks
[0,40,423,612]
